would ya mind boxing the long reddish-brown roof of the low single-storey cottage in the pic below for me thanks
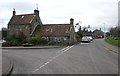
[34,24,70,36]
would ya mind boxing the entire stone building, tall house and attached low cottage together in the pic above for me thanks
[8,9,77,44]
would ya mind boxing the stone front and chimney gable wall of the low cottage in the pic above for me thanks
[41,19,77,44]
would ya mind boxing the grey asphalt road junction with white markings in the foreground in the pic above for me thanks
[2,40,118,75]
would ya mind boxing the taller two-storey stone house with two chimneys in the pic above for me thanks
[8,9,42,37]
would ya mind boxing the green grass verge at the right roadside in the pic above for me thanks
[105,37,120,47]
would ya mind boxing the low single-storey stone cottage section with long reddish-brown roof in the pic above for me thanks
[33,18,77,44]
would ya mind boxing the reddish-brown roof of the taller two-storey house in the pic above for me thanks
[8,14,35,25]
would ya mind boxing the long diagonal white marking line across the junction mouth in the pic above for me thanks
[28,45,74,76]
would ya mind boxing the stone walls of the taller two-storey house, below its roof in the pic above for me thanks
[8,16,42,38]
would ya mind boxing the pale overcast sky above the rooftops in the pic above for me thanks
[0,0,119,31]
